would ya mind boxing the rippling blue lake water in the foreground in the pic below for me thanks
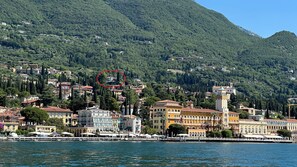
[0,142,297,167]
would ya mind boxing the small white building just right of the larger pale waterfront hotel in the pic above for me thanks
[120,115,141,134]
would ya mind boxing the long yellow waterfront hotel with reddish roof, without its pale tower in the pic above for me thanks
[150,100,239,137]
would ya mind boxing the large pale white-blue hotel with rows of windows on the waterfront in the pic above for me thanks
[78,106,116,133]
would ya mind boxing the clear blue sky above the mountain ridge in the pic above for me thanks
[195,0,297,38]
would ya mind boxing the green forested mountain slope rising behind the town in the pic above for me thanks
[0,0,297,96]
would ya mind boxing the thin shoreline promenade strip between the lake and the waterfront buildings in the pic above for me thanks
[0,137,295,143]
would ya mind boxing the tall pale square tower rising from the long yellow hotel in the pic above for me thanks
[216,88,229,128]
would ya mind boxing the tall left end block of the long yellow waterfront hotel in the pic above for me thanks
[150,100,182,134]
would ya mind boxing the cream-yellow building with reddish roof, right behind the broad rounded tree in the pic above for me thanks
[41,106,73,126]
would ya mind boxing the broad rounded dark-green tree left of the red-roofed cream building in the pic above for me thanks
[21,107,49,124]
